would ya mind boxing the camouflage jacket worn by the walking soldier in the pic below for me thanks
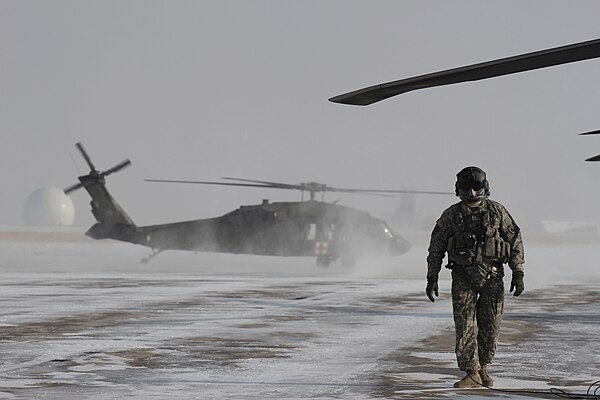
[427,199,524,278]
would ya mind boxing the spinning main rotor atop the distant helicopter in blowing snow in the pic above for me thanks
[146,177,454,201]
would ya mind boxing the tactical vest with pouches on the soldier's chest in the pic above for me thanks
[447,200,510,267]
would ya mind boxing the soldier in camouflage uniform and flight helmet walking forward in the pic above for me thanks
[426,167,525,388]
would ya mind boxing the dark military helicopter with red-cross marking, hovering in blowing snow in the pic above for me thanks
[64,143,452,266]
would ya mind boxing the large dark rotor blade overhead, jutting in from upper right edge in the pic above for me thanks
[329,39,600,106]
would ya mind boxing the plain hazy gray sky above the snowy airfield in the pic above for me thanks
[0,0,600,228]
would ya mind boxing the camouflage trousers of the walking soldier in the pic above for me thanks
[452,268,504,373]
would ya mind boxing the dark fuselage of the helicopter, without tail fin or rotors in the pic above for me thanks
[88,200,410,265]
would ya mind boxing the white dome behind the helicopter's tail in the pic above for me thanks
[23,188,75,226]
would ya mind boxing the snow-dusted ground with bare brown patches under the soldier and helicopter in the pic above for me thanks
[0,229,600,399]
